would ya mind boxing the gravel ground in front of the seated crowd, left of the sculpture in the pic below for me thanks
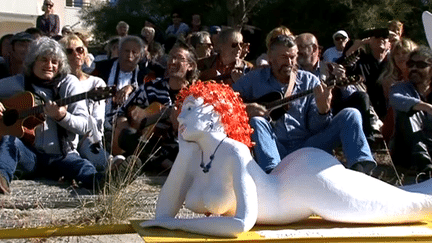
[0,176,199,243]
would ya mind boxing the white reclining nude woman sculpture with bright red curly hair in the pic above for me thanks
[141,82,432,237]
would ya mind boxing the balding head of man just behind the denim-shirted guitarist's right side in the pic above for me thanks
[296,33,319,71]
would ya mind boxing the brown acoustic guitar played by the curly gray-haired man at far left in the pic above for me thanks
[0,87,115,144]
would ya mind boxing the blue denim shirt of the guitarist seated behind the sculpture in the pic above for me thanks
[232,67,332,148]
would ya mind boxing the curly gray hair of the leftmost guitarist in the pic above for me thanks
[24,36,70,76]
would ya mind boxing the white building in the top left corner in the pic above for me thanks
[0,0,106,37]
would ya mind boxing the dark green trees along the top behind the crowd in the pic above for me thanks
[82,0,431,50]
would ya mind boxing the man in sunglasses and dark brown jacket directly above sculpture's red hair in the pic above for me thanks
[198,29,253,85]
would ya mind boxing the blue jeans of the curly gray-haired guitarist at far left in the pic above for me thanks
[0,136,104,188]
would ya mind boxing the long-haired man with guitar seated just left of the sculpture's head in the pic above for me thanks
[113,42,198,170]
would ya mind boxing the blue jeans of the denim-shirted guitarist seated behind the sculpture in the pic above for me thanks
[250,108,375,172]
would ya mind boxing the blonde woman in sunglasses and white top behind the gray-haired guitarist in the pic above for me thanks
[60,34,107,171]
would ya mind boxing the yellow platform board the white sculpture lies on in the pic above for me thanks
[131,217,432,243]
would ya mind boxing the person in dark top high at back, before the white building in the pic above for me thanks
[36,0,60,37]
